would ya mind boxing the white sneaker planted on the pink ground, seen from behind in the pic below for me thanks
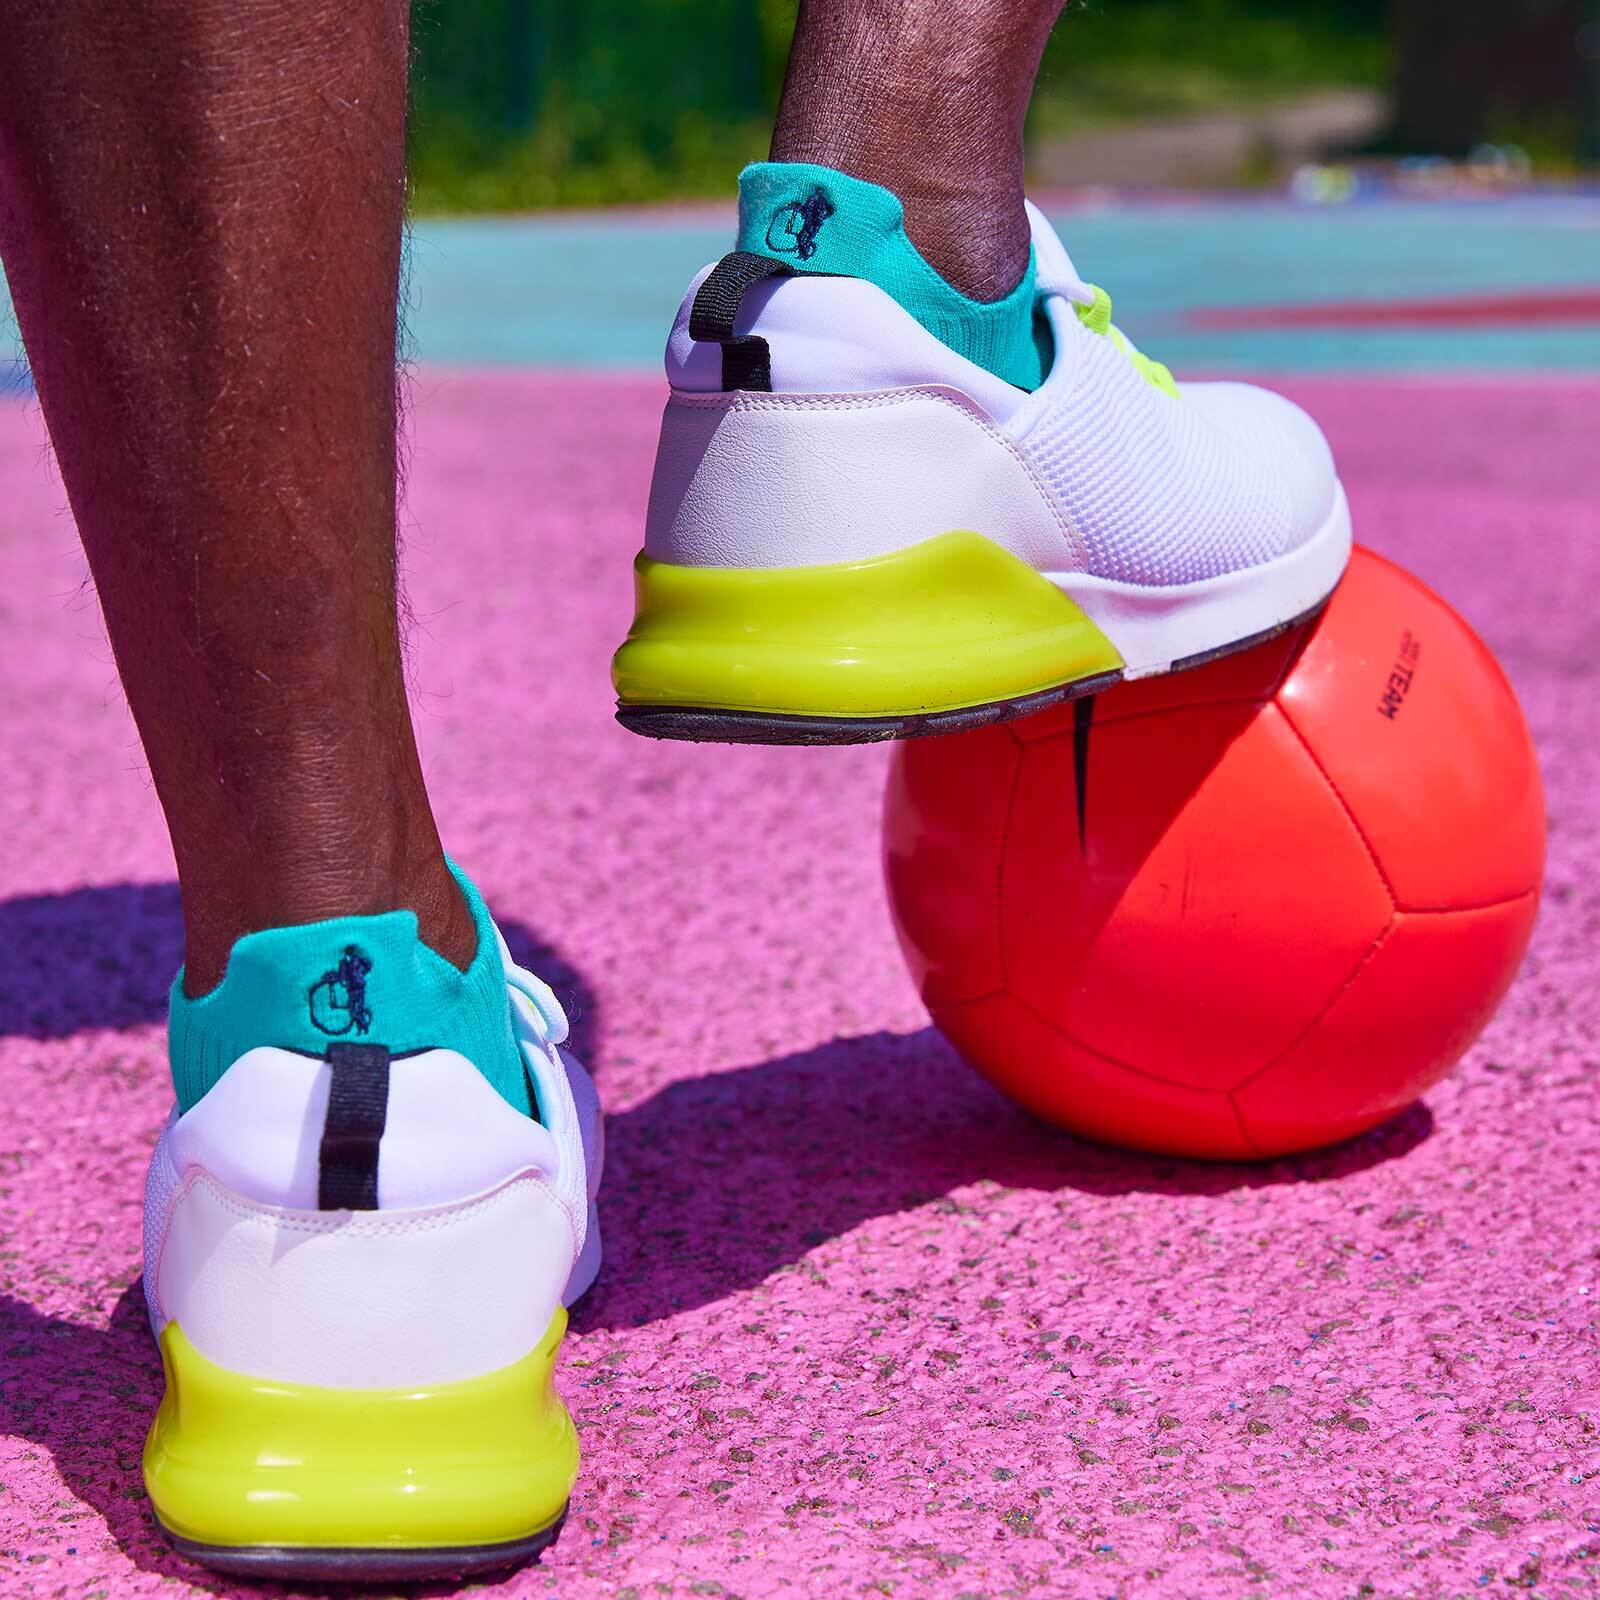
[144,942,602,1581]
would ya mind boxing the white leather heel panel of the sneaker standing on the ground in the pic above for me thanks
[154,1171,576,1389]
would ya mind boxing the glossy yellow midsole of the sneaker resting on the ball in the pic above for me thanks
[611,531,1122,717]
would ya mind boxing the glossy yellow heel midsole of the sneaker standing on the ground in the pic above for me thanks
[144,1310,578,1549]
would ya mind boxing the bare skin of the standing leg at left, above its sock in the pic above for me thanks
[0,0,475,994]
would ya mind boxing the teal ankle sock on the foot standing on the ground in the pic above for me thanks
[166,862,530,1112]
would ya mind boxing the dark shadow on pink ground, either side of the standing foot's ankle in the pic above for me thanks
[0,883,595,1056]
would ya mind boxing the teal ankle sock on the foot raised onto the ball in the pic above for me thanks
[738,162,1045,389]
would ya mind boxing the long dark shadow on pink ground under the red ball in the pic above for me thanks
[574,1027,1434,1331]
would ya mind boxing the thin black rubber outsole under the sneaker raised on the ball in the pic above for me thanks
[616,600,1328,744]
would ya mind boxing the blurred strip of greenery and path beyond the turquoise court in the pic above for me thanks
[413,0,1600,213]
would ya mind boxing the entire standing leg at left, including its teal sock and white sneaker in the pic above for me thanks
[0,21,600,1584]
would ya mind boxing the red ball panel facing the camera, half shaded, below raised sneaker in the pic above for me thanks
[1000,706,1390,1090]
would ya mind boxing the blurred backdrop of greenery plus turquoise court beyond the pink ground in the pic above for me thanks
[0,0,1600,394]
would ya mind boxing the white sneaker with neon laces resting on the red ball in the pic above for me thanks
[613,206,1350,744]
